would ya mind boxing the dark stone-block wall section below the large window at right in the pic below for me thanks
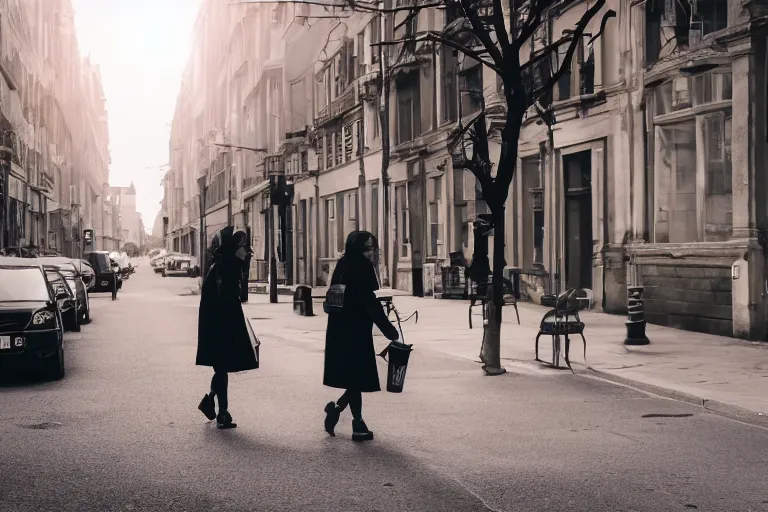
[637,264,733,336]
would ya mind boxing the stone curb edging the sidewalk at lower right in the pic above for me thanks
[577,368,768,428]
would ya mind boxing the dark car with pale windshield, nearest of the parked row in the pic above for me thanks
[0,257,68,380]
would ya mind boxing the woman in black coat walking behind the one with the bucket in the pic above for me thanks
[196,226,258,429]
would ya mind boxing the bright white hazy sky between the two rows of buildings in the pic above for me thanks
[73,0,200,230]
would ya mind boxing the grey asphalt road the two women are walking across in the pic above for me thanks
[0,261,768,512]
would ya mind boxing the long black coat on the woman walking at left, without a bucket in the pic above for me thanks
[197,256,258,372]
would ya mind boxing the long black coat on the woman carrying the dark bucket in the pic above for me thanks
[323,236,399,392]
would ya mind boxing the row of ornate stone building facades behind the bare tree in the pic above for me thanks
[166,0,768,340]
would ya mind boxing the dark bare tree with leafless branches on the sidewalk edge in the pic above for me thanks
[242,0,616,375]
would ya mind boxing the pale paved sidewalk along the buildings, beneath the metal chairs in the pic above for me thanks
[244,290,768,425]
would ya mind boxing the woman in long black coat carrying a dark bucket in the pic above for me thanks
[323,231,399,441]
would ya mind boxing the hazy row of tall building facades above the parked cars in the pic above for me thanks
[0,0,112,256]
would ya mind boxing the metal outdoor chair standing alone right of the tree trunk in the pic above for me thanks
[536,288,589,372]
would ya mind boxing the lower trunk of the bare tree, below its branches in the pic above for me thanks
[480,203,506,375]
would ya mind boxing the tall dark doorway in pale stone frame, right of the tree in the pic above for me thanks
[563,150,593,290]
